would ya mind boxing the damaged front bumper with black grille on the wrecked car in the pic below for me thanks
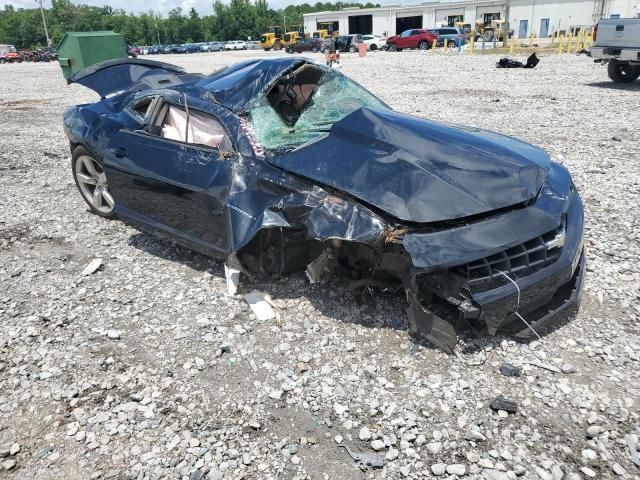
[406,183,585,352]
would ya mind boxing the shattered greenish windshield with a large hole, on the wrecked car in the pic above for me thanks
[248,64,389,151]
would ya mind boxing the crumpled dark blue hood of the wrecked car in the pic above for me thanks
[269,108,550,223]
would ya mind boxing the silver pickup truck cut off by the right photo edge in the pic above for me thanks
[591,18,640,83]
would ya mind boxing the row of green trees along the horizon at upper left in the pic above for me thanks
[0,0,380,49]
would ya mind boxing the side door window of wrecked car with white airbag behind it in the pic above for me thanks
[154,104,231,150]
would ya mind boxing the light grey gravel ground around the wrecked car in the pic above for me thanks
[0,52,640,480]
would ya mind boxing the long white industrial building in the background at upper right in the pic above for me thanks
[304,0,640,38]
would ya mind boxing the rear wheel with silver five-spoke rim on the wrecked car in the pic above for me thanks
[71,146,116,218]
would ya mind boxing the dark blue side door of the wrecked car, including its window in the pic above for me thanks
[104,98,236,255]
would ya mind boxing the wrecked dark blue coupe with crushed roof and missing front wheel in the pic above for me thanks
[64,57,585,352]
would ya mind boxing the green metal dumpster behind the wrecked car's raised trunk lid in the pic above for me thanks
[58,31,127,80]
